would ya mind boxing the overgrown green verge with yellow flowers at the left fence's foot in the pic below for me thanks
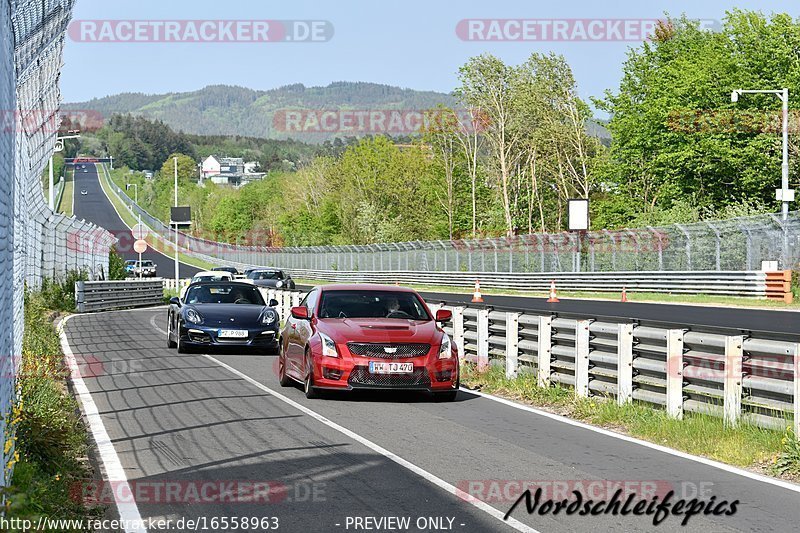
[5,286,103,523]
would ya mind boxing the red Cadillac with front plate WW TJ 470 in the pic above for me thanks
[279,285,459,401]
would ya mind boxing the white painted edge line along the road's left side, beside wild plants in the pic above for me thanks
[58,315,147,533]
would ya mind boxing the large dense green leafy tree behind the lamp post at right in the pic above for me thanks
[597,10,800,221]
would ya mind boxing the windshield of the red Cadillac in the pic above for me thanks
[319,291,431,320]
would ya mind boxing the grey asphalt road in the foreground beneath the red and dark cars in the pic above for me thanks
[65,308,800,533]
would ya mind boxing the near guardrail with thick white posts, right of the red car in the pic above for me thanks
[269,290,800,434]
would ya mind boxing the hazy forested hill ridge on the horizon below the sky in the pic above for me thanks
[63,81,610,143]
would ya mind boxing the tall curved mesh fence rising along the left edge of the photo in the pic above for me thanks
[0,0,115,486]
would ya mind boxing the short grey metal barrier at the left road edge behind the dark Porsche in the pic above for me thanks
[75,279,164,313]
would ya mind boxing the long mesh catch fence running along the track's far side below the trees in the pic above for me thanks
[104,166,800,272]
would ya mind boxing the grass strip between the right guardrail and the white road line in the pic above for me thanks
[461,363,800,480]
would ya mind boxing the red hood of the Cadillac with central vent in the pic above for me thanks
[317,318,441,344]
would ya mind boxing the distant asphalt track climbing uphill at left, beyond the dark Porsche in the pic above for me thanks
[74,164,200,278]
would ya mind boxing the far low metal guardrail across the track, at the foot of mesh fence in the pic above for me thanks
[282,269,767,298]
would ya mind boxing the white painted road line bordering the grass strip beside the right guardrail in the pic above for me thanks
[461,387,800,492]
